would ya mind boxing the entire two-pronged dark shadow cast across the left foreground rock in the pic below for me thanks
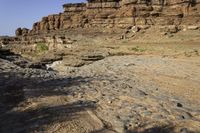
[0,72,96,133]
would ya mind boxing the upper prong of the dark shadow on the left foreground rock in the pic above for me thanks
[0,72,90,113]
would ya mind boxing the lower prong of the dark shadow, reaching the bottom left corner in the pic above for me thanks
[0,101,96,133]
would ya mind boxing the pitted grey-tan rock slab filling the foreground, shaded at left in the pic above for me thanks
[0,55,200,133]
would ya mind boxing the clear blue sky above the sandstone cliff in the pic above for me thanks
[0,0,85,36]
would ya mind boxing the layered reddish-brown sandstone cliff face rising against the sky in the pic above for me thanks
[16,0,200,36]
